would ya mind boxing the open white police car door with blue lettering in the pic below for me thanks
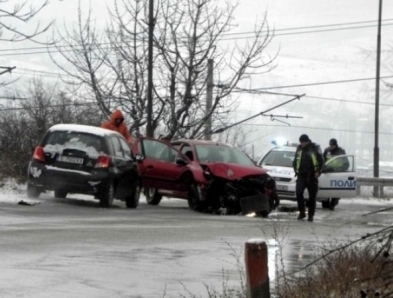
[318,155,356,198]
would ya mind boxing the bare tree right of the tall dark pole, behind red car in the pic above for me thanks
[155,0,274,138]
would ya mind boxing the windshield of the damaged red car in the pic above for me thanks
[195,145,255,166]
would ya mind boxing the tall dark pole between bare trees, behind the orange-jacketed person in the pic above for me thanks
[146,0,154,137]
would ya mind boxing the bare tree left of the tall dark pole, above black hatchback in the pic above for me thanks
[51,0,155,134]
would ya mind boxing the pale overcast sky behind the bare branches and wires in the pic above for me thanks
[0,0,393,161]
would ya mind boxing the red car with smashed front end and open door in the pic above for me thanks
[132,137,279,216]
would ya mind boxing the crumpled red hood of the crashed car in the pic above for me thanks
[206,163,267,180]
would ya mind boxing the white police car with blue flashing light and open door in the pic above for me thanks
[258,142,356,210]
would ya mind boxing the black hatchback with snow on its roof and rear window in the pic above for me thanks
[27,124,141,208]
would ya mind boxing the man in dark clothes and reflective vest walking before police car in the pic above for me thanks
[293,134,324,222]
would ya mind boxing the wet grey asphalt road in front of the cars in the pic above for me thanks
[0,194,393,298]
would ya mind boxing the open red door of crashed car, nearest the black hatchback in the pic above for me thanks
[133,138,188,191]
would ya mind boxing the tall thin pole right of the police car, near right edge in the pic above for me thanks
[374,0,382,197]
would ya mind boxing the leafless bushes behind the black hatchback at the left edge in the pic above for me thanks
[0,78,103,177]
